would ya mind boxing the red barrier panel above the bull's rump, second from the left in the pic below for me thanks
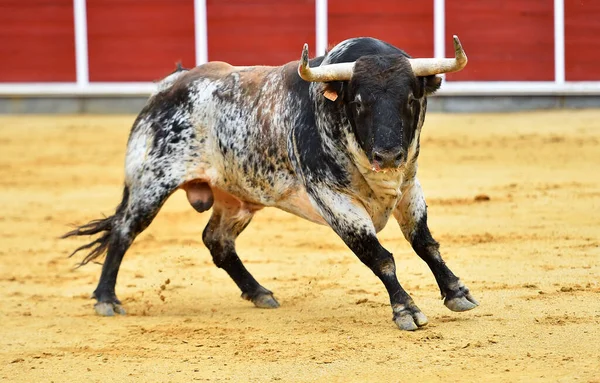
[87,0,195,82]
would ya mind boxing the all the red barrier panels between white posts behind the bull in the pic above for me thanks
[0,0,600,82]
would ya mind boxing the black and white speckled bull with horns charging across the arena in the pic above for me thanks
[64,36,478,330]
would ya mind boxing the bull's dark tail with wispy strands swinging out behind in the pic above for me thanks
[61,186,129,267]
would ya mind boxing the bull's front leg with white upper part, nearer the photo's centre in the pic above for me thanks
[309,188,427,330]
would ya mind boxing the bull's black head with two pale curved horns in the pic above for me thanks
[298,36,467,170]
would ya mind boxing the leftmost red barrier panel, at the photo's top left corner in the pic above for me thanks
[0,0,76,82]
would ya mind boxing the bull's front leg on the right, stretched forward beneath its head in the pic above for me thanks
[394,177,479,311]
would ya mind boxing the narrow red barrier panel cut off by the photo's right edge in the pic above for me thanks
[565,0,600,81]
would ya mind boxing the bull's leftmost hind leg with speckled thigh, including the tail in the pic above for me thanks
[66,103,201,316]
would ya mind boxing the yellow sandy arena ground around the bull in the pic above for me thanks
[0,111,600,382]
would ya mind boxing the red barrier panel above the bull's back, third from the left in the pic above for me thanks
[206,0,315,65]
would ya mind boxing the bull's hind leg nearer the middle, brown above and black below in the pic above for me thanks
[202,200,279,308]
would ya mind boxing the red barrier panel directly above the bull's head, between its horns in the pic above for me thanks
[329,0,433,57]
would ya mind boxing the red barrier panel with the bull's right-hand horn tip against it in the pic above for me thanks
[446,0,554,81]
